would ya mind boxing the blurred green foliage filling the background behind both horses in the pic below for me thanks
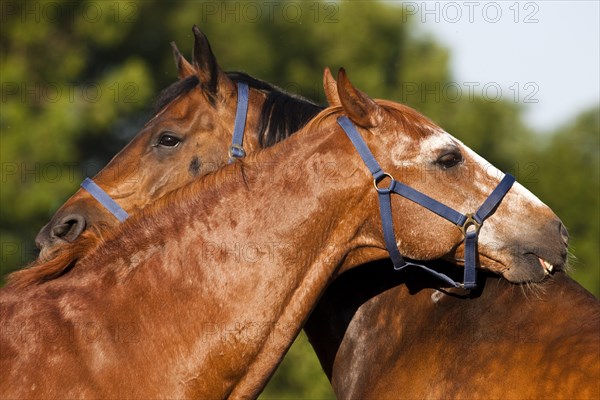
[0,0,600,399]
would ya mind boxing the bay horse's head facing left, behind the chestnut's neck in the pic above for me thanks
[36,27,282,258]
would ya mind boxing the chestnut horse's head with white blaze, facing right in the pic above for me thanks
[324,70,568,282]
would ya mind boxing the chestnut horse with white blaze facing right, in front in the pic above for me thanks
[0,70,566,398]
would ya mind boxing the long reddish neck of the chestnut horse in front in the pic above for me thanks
[7,125,369,397]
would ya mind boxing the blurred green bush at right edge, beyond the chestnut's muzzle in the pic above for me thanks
[524,106,600,296]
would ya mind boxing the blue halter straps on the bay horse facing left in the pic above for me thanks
[80,82,248,222]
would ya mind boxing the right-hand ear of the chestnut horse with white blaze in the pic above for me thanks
[337,68,383,128]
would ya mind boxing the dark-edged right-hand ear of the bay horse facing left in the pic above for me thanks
[192,25,236,97]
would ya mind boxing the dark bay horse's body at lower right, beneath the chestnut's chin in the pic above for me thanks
[305,74,600,399]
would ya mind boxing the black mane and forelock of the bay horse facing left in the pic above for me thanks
[154,72,325,147]
